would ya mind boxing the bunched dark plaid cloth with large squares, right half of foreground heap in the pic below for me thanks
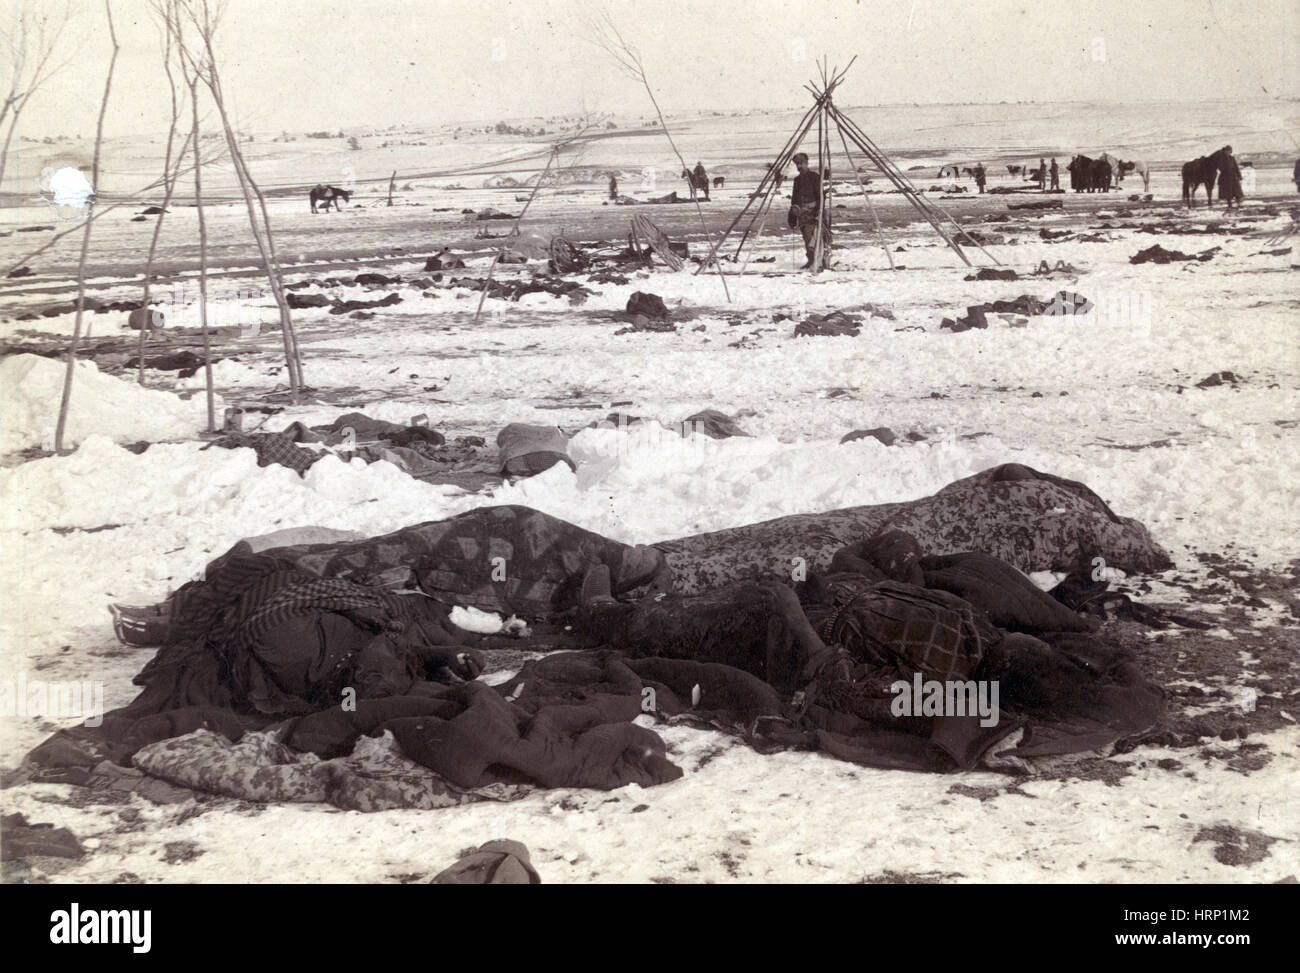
[822,581,984,680]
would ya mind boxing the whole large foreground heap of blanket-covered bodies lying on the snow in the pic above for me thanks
[9,466,1171,810]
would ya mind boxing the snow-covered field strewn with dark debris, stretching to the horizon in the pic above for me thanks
[0,107,1300,882]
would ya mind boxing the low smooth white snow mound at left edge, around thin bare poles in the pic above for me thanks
[0,355,221,453]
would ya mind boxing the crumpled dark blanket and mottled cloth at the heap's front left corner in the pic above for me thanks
[10,653,691,810]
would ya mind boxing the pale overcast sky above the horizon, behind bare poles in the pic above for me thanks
[20,0,1300,135]
